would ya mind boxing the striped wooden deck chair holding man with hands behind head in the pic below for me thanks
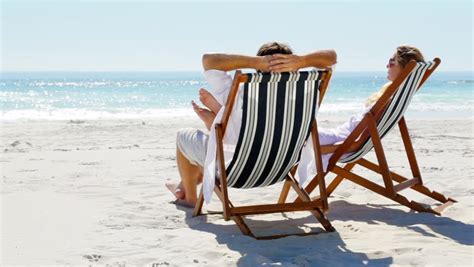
[194,70,334,239]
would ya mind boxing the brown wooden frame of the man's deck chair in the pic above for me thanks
[193,69,335,239]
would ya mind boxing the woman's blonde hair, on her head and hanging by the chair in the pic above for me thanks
[365,45,425,106]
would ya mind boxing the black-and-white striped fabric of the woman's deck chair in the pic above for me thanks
[338,61,435,163]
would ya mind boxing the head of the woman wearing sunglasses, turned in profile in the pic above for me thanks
[387,45,425,81]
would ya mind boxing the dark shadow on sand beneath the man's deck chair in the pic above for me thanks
[178,204,393,266]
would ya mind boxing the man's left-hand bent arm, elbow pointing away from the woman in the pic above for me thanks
[202,54,271,71]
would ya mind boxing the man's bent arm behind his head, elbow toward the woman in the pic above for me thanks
[269,50,337,72]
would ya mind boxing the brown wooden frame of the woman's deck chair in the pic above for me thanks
[282,58,456,215]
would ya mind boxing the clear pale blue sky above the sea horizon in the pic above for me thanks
[0,0,473,71]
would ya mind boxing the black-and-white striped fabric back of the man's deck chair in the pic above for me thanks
[226,70,330,188]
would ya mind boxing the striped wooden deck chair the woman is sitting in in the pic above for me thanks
[295,58,456,215]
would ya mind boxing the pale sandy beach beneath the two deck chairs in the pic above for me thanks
[0,117,474,266]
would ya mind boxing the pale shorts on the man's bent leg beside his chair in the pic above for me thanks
[176,128,209,167]
